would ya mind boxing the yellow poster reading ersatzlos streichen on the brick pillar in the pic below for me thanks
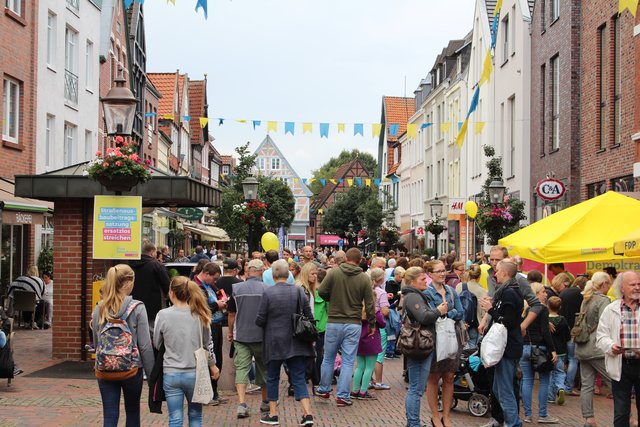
[93,196,142,260]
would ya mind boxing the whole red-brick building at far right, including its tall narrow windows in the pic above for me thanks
[580,0,638,199]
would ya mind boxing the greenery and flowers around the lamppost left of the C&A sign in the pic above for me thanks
[476,145,527,245]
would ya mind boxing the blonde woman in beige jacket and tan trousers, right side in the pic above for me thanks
[571,271,611,427]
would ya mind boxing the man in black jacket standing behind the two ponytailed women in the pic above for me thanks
[129,242,170,338]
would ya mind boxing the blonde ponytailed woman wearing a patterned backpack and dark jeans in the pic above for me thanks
[91,264,153,427]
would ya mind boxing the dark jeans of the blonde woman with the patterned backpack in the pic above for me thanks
[98,368,142,427]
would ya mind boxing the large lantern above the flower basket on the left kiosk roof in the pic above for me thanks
[100,67,138,136]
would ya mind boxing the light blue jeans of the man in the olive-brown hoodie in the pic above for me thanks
[318,323,362,399]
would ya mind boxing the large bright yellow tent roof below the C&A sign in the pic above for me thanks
[499,191,640,264]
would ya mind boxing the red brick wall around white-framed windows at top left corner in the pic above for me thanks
[0,0,38,179]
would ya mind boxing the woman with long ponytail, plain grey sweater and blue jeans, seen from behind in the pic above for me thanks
[153,276,220,427]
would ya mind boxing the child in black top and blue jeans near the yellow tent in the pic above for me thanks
[547,296,571,405]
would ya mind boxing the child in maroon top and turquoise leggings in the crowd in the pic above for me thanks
[351,307,385,400]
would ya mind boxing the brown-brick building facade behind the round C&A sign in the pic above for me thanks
[528,0,582,222]
